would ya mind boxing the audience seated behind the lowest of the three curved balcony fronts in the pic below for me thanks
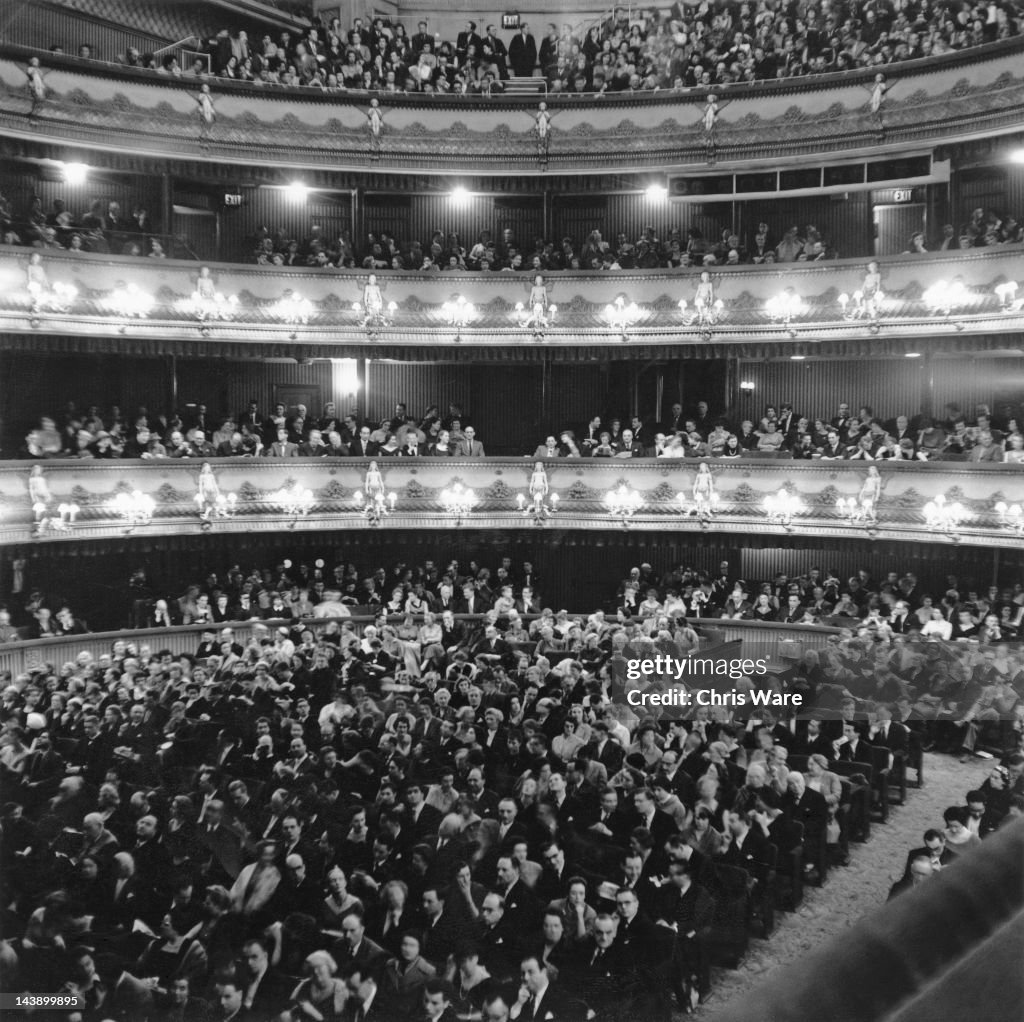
[18,400,1024,466]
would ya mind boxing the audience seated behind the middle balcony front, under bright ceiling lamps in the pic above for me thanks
[0,185,1024,273]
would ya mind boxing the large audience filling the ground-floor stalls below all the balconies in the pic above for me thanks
[0,561,1024,1022]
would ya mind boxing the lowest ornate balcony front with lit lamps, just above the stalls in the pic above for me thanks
[0,458,1024,549]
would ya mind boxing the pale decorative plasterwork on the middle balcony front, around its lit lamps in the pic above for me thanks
[0,245,1024,353]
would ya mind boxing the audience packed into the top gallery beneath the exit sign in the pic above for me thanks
[46,0,1024,95]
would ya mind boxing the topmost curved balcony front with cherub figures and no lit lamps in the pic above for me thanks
[6,37,1024,175]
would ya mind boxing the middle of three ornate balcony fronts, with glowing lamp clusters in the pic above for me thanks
[0,245,1024,358]
